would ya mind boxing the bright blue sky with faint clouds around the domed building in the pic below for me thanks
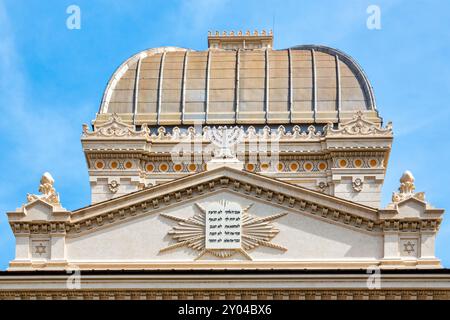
[0,0,450,269]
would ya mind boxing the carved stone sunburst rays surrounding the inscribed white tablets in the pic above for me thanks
[160,201,287,260]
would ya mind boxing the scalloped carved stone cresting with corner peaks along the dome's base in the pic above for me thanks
[82,112,392,144]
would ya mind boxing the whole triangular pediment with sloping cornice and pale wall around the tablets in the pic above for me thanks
[62,167,382,267]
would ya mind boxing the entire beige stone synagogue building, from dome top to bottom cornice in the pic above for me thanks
[0,33,450,299]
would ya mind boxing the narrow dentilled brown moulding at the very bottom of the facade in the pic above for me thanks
[0,288,450,300]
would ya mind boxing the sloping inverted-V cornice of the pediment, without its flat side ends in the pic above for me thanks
[71,166,377,232]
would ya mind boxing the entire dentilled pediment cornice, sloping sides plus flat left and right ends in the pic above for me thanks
[10,167,441,236]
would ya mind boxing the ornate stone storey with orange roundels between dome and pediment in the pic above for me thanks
[82,114,391,206]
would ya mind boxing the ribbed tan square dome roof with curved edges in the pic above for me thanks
[96,45,381,125]
